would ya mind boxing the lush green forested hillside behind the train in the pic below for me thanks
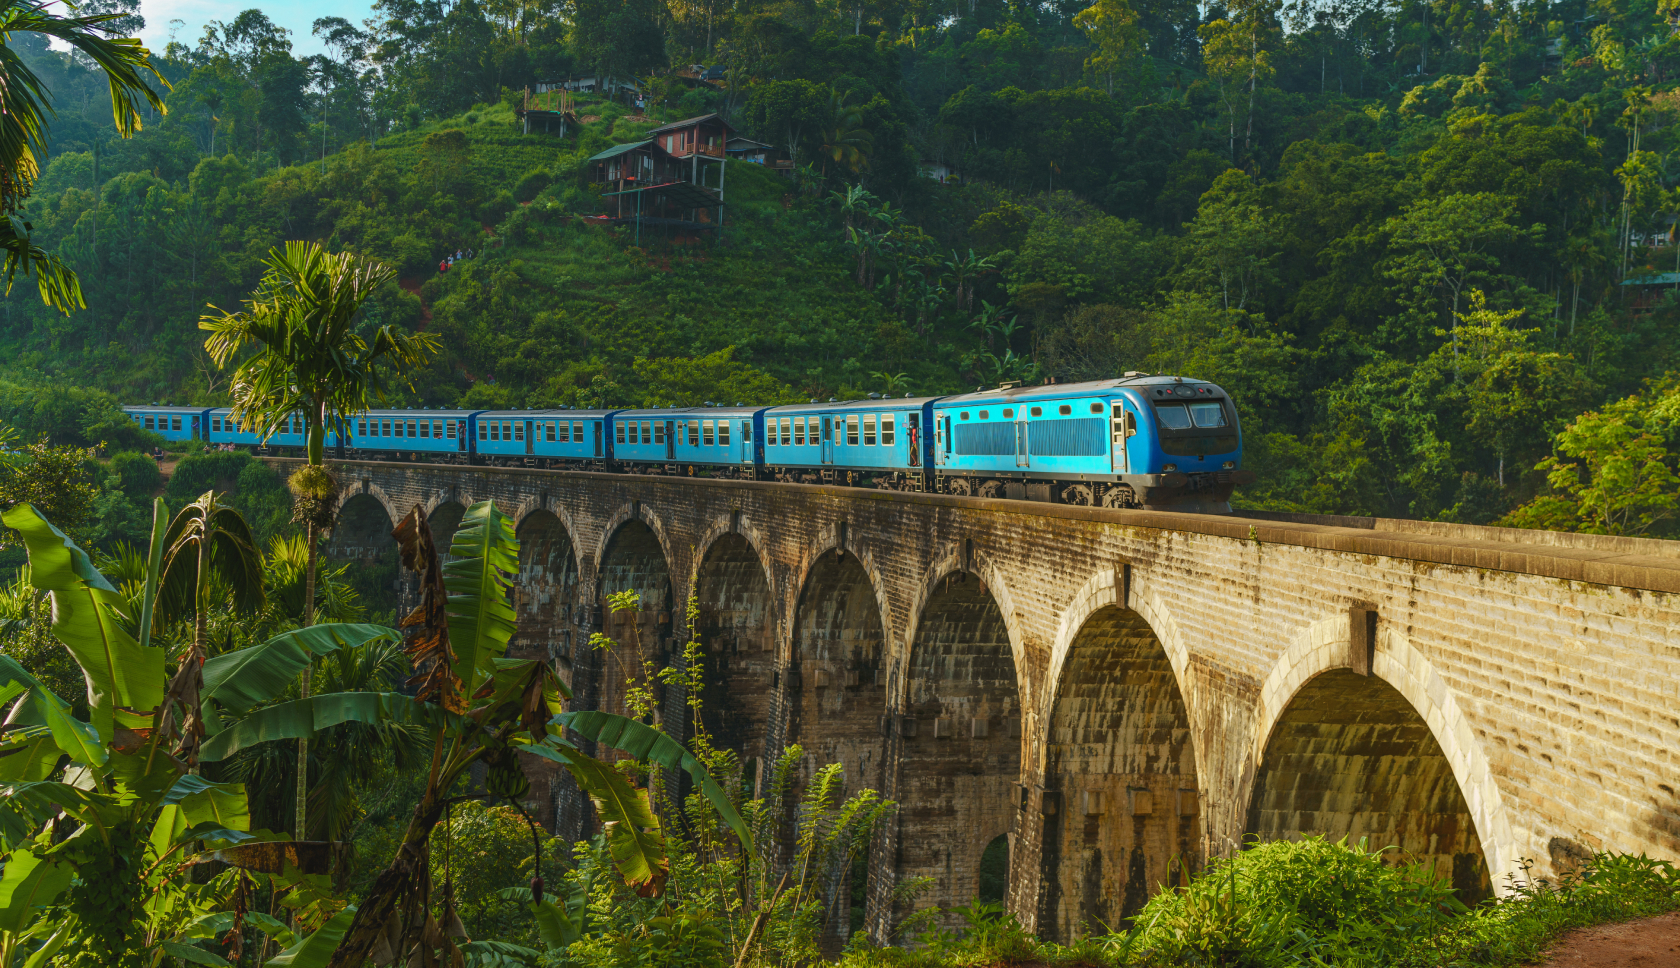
[0,0,1680,533]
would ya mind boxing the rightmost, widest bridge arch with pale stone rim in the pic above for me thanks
[1245,615,1517,901]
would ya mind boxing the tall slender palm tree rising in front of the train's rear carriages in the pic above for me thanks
[198,242,438,830]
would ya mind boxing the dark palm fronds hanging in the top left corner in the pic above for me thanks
[0,0,168,313]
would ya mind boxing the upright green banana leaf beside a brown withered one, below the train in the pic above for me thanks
[444,501,519,696]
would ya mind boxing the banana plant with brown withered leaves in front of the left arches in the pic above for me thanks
[200,501,749,968]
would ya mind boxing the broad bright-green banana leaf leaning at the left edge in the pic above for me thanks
[0,504,163,741]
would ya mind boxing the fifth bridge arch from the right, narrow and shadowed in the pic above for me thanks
[690,524,778,783]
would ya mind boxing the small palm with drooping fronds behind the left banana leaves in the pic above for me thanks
[158,491,265,762]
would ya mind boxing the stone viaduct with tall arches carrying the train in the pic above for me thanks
[288,462,1680,939]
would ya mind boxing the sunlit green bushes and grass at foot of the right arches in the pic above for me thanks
[840,839,1680,968]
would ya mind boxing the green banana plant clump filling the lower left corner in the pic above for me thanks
[0,504,396,968]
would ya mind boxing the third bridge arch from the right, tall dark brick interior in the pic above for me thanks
[892,550,1023,908]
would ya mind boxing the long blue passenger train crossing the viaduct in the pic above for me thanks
[126,373,1252,513]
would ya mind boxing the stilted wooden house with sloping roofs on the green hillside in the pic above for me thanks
[588,114,732,237]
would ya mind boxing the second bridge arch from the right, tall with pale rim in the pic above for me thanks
[1034,570,1205,938]
